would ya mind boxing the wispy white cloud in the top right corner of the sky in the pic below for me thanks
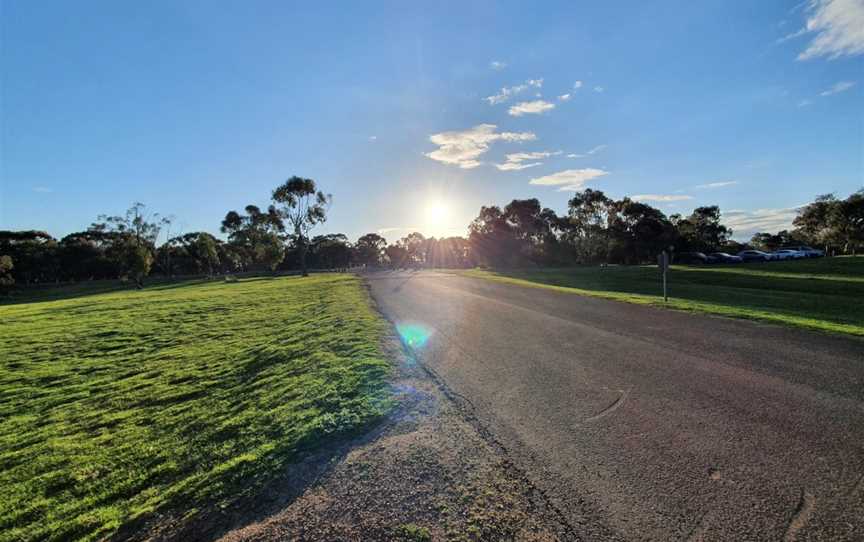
[783,0,864,60]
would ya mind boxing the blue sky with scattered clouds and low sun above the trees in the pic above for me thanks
[0,0,864,241]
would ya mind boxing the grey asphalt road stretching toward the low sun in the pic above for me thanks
[369,272,864,540]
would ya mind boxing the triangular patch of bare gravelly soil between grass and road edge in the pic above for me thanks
[215,340,572,542]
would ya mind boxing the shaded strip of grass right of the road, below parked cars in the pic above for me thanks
[466,257,864,335]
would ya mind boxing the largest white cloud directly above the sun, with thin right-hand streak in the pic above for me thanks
[425,124,537,169]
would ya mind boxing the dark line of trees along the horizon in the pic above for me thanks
[0,183,864,288]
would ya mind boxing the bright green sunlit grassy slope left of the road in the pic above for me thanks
[0,275,390,540]
